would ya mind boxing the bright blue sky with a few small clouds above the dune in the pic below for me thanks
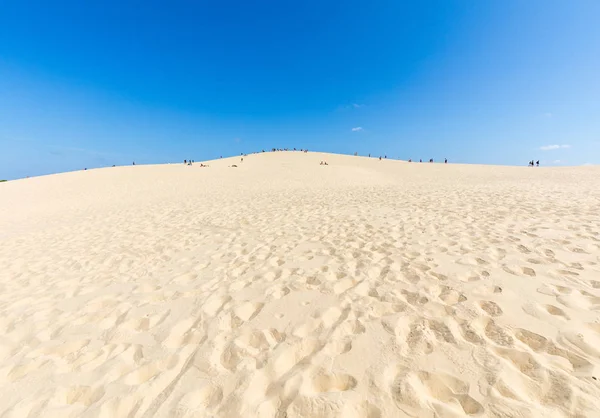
[0,0,600,179]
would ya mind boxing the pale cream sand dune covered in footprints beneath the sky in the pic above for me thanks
[0,152,600,418]
